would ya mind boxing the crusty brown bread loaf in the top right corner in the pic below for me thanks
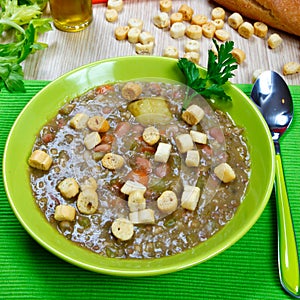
[214,0,300,36]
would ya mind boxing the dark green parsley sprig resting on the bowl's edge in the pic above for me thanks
[178,40,238,109]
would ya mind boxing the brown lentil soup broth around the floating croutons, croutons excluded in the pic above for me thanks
[30,82,250,258]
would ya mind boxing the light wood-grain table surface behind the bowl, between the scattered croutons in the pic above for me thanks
[24,0,300,85]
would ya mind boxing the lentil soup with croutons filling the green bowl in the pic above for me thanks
[29,80,250,259]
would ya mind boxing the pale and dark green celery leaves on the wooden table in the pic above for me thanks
[0,0,52,92]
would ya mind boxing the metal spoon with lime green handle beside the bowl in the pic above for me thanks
[251,71,300,298]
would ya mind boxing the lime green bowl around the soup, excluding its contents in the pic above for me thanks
[3,56,275,276]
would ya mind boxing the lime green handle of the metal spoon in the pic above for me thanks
[275,153,300,298]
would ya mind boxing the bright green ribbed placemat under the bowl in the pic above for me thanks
[0,81,300,300]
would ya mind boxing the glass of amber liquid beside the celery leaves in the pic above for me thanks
[50,0,93,32]
